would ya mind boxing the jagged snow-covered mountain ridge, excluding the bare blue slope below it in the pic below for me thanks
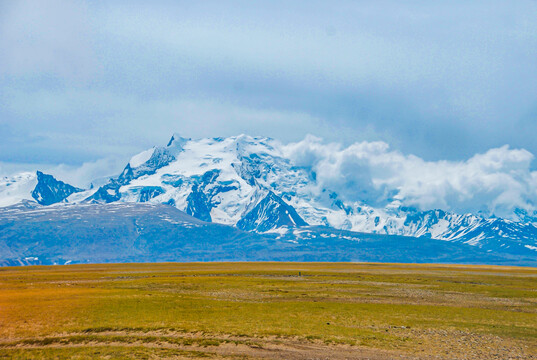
[0,134,537,256]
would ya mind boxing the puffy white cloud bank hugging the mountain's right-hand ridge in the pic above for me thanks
[284,136,537,217]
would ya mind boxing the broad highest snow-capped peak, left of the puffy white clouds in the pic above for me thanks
[81,135,308,231]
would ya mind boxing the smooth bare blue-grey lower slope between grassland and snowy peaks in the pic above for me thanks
[0,202,537,266]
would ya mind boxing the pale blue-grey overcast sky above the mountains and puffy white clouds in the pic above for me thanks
[0,0,537,180]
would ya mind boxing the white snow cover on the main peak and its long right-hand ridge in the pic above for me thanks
[73,135,533,250]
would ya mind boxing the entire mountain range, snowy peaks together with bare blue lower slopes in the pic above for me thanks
[0,134,537,265]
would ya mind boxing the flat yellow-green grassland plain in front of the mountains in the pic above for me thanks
[0,263,537,359]
